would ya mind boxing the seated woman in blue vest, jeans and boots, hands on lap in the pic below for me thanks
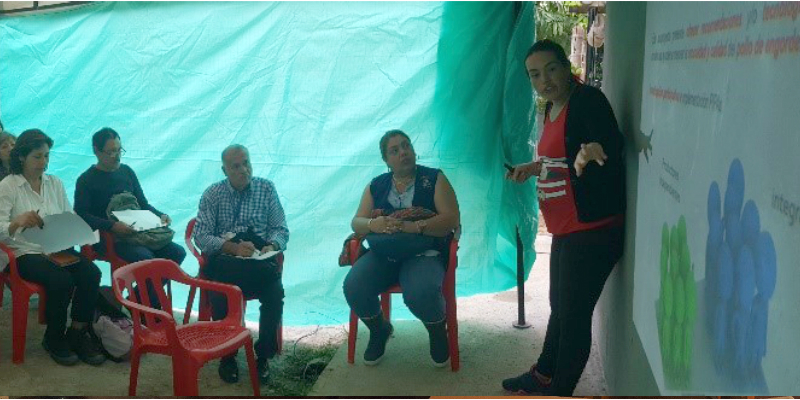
[344,130,460,367]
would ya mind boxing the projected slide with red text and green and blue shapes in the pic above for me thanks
[634,2,800,395]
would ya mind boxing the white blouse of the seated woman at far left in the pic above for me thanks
[0,174,74,265]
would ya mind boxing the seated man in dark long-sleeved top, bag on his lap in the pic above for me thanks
[75,128,186,308]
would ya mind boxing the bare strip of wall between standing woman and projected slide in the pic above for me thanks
[594,2,659,396]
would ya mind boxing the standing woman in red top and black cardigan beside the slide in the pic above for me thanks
[503,40,625,396]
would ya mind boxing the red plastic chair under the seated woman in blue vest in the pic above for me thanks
[347,235,461,372]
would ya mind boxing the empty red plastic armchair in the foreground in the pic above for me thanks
[112,259,261,397]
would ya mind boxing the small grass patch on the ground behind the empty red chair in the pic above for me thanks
[262,344,337,397]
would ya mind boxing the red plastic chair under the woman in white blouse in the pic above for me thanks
[0,243,47,364]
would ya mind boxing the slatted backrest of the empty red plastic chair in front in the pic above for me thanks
[111,258,190,338]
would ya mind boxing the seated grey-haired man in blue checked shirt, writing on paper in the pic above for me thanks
[194,145,289,384]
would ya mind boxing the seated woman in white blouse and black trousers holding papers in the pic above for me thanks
[0,129,105,365]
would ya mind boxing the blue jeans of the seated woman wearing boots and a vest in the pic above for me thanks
[343,252,446,323]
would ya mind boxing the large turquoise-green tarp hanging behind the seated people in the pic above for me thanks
[0,2,537,325]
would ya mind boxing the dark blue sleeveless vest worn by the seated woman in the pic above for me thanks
[369,165,439,214]
